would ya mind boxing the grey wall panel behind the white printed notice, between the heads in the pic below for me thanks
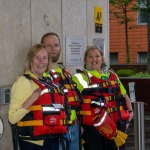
[62,0,87,74]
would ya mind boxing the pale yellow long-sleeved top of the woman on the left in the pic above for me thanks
[8,71,43,145]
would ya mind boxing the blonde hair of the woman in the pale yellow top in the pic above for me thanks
[25,44,51,72]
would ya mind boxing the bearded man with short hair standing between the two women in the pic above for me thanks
[41,32,82,150]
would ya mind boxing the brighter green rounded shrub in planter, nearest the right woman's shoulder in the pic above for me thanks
[116,69,135,77]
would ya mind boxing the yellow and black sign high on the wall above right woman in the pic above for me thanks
[94,6,103,33]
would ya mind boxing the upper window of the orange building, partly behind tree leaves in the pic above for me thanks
[138,0,147,25]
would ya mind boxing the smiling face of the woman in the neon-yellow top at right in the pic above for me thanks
[85,49,103,72]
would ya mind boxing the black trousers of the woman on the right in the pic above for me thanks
[82,126,125,150]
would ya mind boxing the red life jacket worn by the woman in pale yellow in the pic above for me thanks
[17,75,67,139]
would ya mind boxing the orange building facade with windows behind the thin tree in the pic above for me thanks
[110,1,148,65]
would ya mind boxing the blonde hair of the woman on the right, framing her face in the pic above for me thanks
[84,46,105,68]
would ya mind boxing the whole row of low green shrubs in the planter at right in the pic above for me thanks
[116,69,150,78]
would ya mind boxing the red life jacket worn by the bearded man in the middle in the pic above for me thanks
[50,68,82,108]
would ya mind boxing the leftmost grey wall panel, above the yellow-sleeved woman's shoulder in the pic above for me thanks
[0,0,31,86]
